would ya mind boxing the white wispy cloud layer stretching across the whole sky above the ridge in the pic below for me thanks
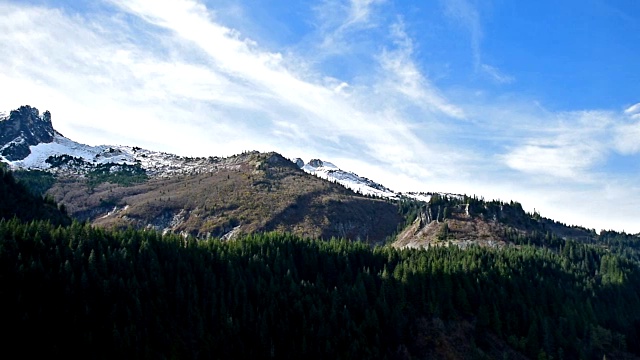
[0,0,640,230]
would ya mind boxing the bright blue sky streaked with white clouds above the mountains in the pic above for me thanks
[0,0,640,232]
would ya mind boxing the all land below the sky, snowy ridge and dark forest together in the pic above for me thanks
[0,105,640,359]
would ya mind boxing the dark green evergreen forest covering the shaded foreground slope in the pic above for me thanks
[0,220,640,359]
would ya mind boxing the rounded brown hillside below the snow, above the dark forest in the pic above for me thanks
[49,152,402,243]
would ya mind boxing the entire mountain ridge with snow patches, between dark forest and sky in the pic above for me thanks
[0,106,616,247]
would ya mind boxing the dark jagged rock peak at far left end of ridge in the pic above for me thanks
[0,105,55,161]
